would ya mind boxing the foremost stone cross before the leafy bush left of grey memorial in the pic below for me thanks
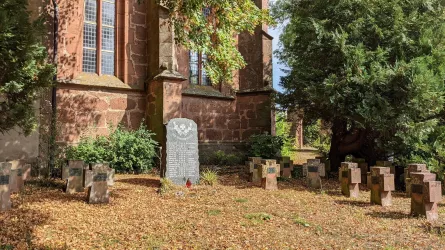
[88,163,110,204]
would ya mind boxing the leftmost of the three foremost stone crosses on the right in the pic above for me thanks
[339,162,361,198]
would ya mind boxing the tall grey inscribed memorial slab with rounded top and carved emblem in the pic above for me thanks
[165,118,199,185]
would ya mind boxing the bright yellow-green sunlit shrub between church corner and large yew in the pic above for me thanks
[275,112,296,156]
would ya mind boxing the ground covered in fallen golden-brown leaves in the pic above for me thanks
[0,171,445,249]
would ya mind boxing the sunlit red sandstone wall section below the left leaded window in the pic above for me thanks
[57,87,146,143]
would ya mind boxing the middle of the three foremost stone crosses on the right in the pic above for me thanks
[371,166,395,206]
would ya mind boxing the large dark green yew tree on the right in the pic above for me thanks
[273,0,445,170]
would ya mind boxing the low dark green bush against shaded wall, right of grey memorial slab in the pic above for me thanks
[248,134,283,159]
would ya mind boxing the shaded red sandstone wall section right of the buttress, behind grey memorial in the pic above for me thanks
[182,94,272,142]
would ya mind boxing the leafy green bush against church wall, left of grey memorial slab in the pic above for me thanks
[66,123,158,173]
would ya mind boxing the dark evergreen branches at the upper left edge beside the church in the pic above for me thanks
[0,0,55,134]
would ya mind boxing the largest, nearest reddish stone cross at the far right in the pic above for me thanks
[411,172,442,220]
